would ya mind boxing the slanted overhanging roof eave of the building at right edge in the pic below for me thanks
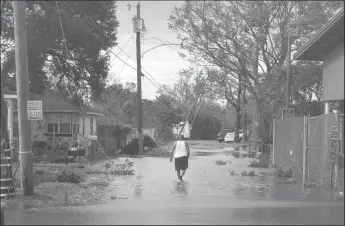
[294,8,344,61]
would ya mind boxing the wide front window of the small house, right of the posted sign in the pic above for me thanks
[46,113,71,134]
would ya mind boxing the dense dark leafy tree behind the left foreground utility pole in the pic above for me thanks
[1,1,119,102]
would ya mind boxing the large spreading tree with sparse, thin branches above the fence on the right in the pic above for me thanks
[169,1,343,139]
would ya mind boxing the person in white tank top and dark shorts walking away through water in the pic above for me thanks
[170,135,190,181]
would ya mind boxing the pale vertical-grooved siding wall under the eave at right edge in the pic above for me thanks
[322,43,344,101]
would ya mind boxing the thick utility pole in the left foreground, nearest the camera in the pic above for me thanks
[13,1,34,196]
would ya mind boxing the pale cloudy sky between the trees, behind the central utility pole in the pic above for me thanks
[109,1,189,99]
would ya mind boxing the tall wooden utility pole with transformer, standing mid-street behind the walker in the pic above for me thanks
[135,2,144,153]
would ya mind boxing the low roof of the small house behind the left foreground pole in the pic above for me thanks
[4,87,101,115]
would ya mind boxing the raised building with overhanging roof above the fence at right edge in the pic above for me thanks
[294,9,344,114]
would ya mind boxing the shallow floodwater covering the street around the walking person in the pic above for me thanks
[5,143,344,225]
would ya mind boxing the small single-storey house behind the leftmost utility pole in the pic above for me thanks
[4,87,101,149]
